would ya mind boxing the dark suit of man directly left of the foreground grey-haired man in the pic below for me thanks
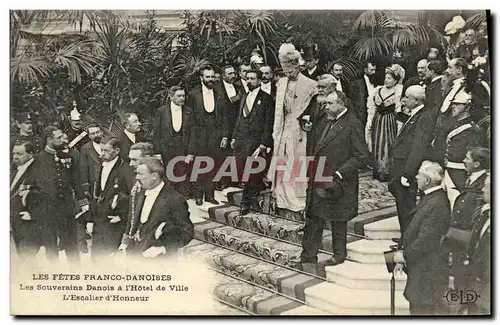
[92,158,129,258]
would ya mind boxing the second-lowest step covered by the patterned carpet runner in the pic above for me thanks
[183,240,324,302]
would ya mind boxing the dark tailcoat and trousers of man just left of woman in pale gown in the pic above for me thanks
[232,89,274,206]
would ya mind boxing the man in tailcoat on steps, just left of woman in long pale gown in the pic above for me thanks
[231,70,274,214]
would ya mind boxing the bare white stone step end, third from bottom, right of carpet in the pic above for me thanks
[347,239,394,265]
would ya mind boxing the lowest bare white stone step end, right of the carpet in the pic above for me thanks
[305,282,409,316]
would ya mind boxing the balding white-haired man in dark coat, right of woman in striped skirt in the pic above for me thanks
[389,85,434,235]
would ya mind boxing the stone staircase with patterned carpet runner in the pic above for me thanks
[183,174,409,315]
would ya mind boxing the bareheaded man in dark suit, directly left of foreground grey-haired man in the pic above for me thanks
[92,137,129,260]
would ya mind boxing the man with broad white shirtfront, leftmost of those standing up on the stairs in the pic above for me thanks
[153,86,196,197]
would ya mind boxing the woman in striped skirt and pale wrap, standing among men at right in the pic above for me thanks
[365,64,405,182]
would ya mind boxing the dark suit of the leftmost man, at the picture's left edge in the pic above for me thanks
[10,161,41,257]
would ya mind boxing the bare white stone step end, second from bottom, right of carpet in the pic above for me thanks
[325,261,406,292]
